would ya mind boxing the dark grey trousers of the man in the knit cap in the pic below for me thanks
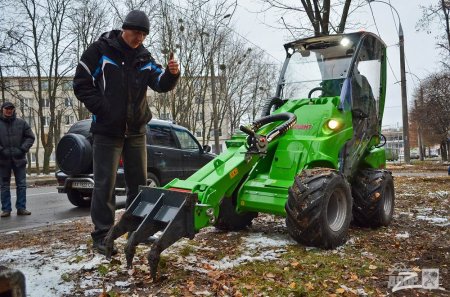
[91,134,147,242]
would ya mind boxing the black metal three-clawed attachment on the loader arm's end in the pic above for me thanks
[105,186,197,280]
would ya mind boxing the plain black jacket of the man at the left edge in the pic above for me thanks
[0,113,34,176]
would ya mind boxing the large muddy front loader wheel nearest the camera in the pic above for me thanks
[285,168,352,249]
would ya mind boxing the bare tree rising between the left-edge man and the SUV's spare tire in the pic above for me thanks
[9,0,73,173]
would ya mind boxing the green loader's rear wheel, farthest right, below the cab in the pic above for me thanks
[352,169,395,228]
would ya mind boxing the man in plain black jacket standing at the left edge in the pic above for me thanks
[0,102,34,218]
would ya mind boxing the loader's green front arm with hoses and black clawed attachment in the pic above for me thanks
[106,112,297,278]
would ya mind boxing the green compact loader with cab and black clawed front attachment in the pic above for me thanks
[106,32,394,278]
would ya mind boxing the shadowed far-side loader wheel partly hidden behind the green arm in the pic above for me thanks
[214,197,258,231]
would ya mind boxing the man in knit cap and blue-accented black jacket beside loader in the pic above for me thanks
[73,10,180,254]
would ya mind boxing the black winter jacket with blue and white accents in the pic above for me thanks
[73,30,179,137]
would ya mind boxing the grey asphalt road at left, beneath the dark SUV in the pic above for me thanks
[0,186,125,234]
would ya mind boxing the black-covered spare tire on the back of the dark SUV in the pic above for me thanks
[56,133,92,175]
